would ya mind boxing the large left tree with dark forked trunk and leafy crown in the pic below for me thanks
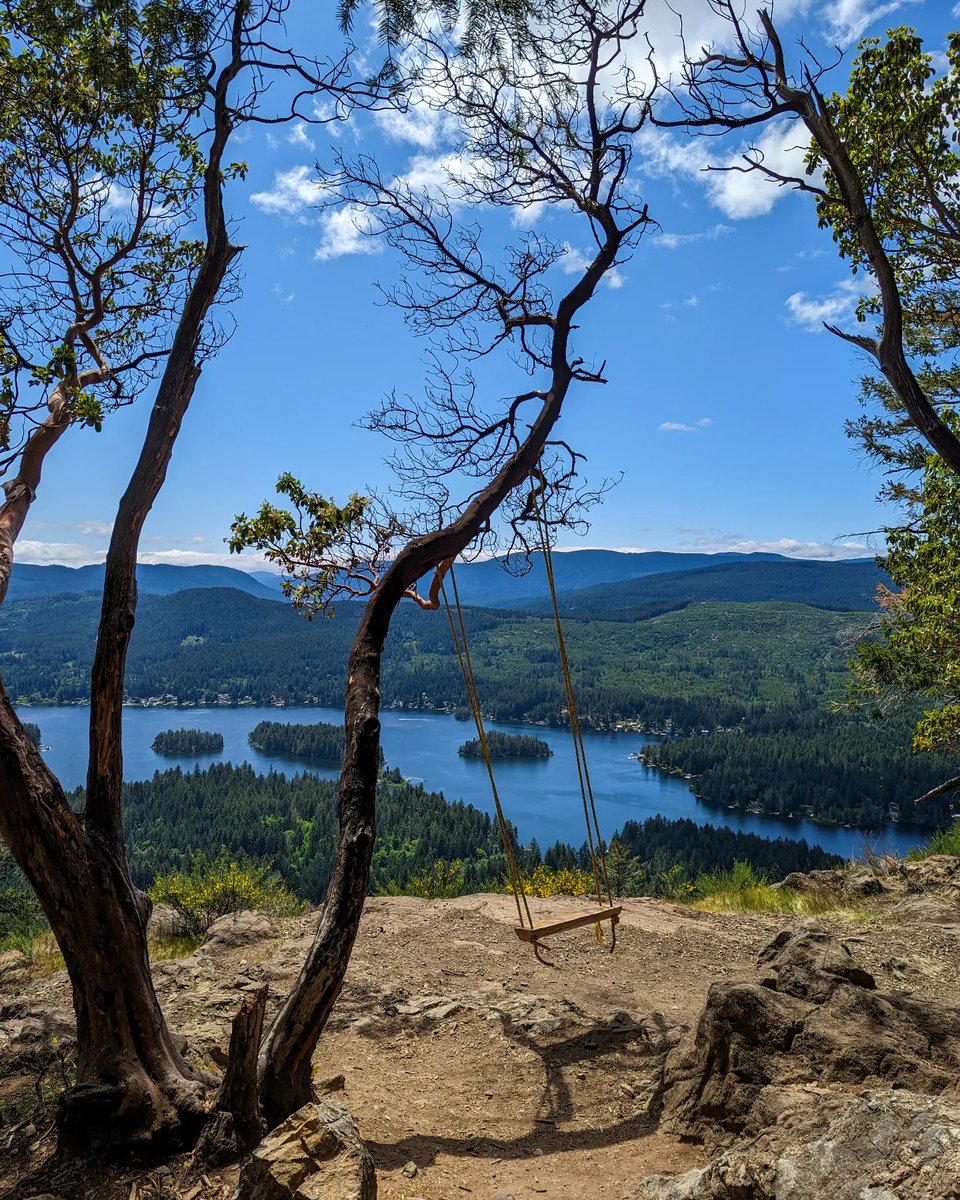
[0,0,378,1154]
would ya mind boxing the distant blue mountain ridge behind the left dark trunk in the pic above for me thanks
[8,563,282,600]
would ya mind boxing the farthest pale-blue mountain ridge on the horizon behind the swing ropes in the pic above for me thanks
[446,550,792,608]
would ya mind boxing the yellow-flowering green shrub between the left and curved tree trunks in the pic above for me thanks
[149,848,306,934]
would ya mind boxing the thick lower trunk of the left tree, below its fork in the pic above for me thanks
[0,685,204,1156]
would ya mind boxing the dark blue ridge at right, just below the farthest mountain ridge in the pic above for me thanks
[511,556,893,620]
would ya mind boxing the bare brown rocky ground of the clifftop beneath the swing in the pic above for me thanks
[0,859,960,1200]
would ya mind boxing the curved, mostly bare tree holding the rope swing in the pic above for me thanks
[232,0,652,1124]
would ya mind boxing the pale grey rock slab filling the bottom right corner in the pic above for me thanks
[636,1091,960,1200]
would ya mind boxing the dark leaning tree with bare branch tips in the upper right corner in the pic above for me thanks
[650,0,960,474]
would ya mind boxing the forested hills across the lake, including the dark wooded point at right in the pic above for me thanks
[0,583,956,828]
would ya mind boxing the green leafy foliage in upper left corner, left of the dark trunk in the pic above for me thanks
[0,0,206,449]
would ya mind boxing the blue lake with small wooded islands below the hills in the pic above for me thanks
[20,707,924,858]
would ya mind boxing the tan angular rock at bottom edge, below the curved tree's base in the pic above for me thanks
[238,1100,377,1200]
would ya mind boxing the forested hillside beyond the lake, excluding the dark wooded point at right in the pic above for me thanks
[0,590,866,731]
